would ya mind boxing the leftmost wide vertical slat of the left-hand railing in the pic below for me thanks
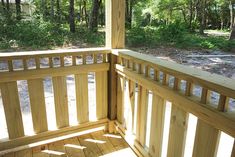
[0,82,24,139]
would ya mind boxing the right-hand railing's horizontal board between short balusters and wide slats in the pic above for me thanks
[116,65,235,137]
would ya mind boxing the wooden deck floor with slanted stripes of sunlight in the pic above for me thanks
[1,131,137,157]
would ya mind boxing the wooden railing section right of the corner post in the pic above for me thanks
[112,50,235,157]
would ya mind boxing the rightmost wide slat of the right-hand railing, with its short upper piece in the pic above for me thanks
[193,88,220,157]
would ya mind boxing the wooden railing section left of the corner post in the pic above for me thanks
[0,48,110,151]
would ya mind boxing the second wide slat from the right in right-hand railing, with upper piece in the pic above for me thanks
[167,78,188,157]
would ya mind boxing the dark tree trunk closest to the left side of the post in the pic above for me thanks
[88,0,99,32]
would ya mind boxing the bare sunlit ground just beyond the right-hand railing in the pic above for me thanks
[131,47,235,79]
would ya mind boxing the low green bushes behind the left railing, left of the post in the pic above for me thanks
[0,19,104,49]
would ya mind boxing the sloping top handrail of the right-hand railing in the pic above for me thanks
[112,49,235,98]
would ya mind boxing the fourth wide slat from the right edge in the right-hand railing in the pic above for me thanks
[137,86,149,147]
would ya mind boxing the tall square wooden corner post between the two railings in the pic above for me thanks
[105,0,125,120]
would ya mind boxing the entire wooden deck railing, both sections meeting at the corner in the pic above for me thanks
[0,48,235,157]
